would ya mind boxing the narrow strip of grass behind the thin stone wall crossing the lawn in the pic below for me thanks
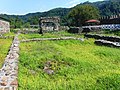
[19,31,83,40]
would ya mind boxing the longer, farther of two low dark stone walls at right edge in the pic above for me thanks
[84,34,120,42]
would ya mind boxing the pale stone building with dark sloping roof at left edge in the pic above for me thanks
[0,17,10,33]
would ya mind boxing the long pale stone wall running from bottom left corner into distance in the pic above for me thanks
[0,34,19,90]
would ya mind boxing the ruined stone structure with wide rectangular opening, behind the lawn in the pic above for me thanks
[39,17,60,34]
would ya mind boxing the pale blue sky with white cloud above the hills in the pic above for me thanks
[0,0,103,15]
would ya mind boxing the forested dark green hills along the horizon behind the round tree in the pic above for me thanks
[0,0,120,24]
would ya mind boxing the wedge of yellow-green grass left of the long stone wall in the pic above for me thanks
[0,39,12,68]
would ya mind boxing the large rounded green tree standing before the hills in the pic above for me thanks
[68,4,100,26]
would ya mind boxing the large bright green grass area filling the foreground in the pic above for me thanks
[18,39,120,90]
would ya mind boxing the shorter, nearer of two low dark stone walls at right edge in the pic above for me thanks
[95,40,120,48]
